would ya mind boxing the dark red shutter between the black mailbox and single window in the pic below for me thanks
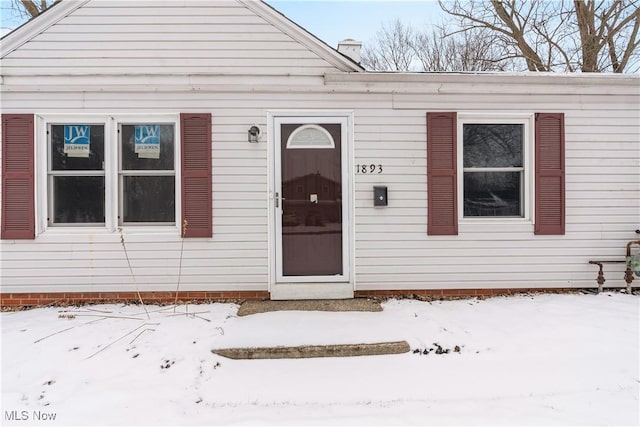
[427,113,458,236]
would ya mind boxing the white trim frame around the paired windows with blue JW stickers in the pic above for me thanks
[35,113,182,235]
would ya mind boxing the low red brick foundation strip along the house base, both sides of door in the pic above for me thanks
[0,288,608,310]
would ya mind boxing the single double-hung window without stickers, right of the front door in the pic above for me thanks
[459,117,530,218]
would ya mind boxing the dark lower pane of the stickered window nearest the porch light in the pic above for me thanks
[122,176,175,222]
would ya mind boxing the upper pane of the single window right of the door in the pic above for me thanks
[463,124,524,168]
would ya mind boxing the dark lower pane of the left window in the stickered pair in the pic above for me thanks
[53,176,104,224]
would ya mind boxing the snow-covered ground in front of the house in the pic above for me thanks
[0,293,640,426]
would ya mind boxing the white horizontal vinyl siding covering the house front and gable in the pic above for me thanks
[0,1,640,292]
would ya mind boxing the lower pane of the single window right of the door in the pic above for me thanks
[464,172,522,217]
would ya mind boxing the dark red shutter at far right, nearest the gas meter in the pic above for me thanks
[535,113,565,234]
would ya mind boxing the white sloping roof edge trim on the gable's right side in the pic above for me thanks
[237,0,365,72]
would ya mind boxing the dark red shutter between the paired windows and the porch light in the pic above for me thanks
[180,113,212,237]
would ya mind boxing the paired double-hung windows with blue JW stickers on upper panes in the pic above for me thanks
[41,117,178,229]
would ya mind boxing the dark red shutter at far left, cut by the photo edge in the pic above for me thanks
[0,114,36,239]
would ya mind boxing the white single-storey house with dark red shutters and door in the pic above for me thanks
[0,0,640,306]
